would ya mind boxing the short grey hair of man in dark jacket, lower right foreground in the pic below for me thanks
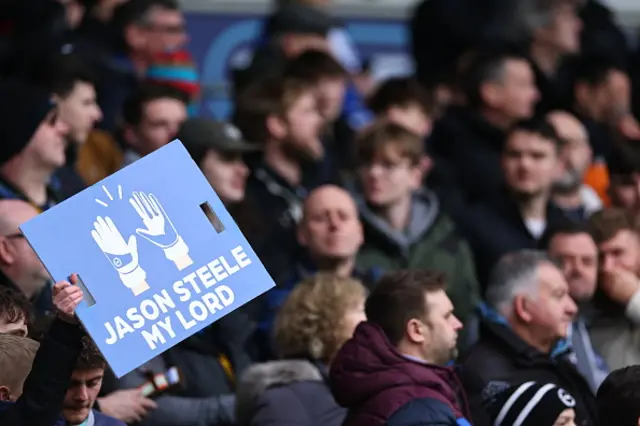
[486,250,555,316]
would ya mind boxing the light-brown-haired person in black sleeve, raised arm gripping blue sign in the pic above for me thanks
[0,275,84,426]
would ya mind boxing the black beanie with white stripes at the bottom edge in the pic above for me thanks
[483,382,576,426]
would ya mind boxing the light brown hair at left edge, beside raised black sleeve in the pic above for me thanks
[0,334,40,394]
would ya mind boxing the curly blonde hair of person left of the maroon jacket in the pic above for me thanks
[274,273,367,363]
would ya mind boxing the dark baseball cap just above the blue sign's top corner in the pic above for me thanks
[178,117,260,162]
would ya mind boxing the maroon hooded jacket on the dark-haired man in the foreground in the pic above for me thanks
[330,322,470,426]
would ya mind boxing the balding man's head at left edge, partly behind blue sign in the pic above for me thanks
[0,200,50,310]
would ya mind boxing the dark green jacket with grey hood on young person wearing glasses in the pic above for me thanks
[356,191,480,346]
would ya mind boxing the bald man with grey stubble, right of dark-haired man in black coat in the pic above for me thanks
[547,111,602,221]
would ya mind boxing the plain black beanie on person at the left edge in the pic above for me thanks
[0,80,53,165]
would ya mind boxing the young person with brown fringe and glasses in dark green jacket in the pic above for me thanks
[354,120,480,347]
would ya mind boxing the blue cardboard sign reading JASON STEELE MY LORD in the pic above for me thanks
[20,140,274,377]
